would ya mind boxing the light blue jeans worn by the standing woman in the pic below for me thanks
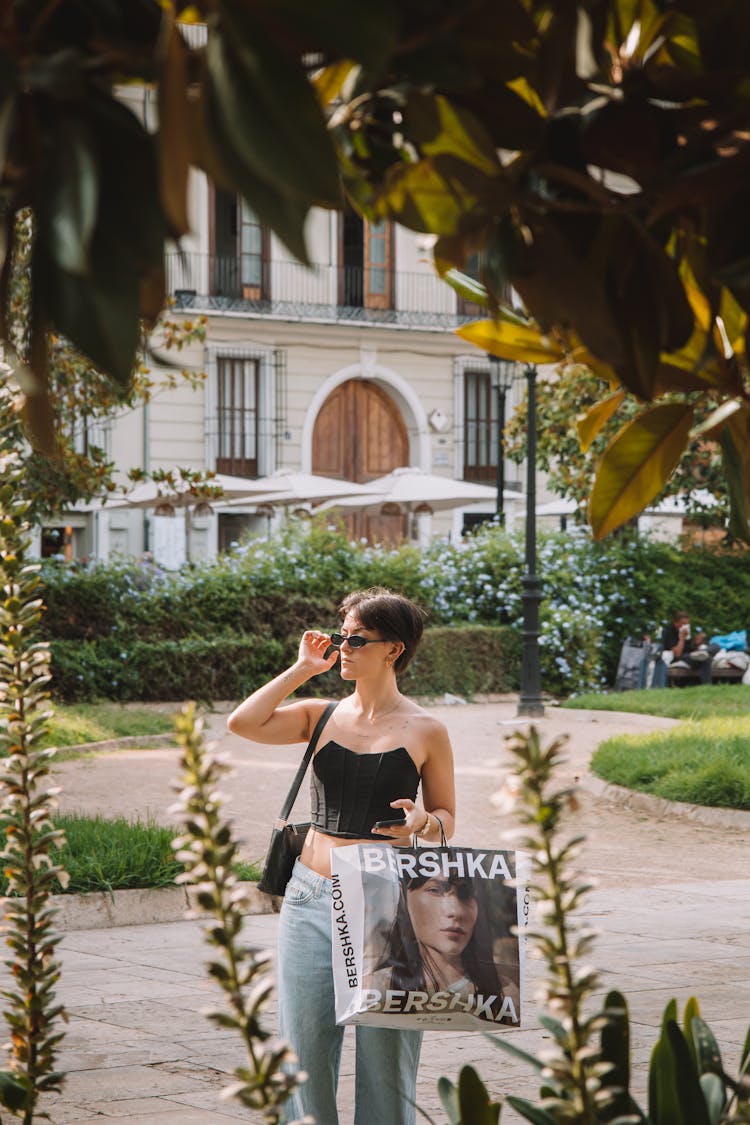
[278,860,422,1125]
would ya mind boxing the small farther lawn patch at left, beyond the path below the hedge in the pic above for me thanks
[39,703,173,747]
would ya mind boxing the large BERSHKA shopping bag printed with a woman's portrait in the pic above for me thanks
[331,843,530,1031]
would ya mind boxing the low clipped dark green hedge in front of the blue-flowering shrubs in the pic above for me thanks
[51,626,518,702]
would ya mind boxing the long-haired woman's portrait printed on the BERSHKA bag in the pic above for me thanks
[376,875,513,1023]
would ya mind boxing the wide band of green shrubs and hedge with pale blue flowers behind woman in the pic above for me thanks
[38,521,750,701]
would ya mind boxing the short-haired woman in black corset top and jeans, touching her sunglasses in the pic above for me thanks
[228,587,455,1125]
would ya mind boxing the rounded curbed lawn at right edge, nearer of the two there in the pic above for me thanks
[590,720,750,809]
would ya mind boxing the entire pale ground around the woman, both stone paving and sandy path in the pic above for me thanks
[22,701,750,1125]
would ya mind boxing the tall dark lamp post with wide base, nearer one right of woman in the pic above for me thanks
[516,365,544,717]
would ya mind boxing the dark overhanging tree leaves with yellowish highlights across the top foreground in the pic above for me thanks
[7,0,750,539]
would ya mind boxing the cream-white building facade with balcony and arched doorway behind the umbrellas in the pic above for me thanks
[44,84,546,566]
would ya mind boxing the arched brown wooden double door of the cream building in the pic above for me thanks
[313,379,409,542]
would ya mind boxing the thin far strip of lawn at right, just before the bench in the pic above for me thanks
[562,684,750,719]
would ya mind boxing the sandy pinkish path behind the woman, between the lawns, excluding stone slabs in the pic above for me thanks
[49,702,747,887]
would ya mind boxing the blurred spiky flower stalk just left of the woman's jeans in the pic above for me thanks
[173,704,304,1125]
